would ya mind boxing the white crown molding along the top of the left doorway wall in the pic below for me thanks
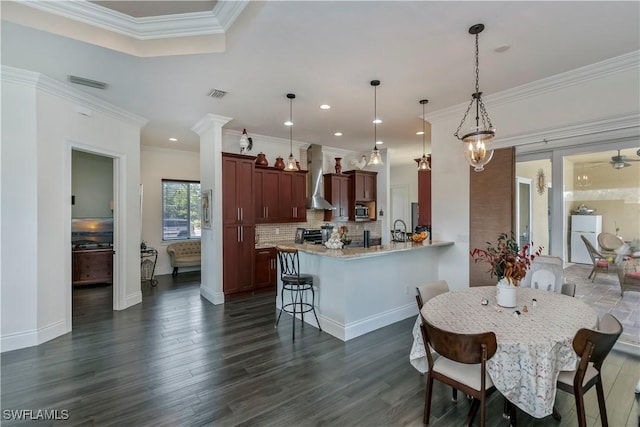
[0,65,148,128]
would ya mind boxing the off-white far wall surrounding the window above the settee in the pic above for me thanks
[140,146,199,274]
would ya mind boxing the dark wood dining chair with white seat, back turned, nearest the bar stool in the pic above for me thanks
[422,316,497,427]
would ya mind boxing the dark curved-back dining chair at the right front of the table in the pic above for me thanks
[553,313,622,427]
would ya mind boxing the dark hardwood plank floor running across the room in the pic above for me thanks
[1,273,640,427]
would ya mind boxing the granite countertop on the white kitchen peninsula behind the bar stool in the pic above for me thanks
[256,240,453,259]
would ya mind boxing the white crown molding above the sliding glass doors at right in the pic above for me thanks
[426,51,640,123]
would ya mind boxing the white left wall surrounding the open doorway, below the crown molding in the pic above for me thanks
[0,67,144,351]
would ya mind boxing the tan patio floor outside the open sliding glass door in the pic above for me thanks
[564,264,640,346]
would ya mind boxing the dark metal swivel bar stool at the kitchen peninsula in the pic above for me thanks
[275,247,322,341]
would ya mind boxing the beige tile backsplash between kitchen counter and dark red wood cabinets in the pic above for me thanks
[256,209,382,243]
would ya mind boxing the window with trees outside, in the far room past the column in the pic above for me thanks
[162,179,200,240]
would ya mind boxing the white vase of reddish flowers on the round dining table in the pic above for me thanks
[469,233,542,307]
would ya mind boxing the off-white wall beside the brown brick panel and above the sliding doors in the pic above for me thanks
[427,52,640,288]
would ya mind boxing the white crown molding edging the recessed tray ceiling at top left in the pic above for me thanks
[21,0,249,40]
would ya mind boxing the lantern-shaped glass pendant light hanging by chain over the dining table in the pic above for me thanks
[454,24,496,172]
